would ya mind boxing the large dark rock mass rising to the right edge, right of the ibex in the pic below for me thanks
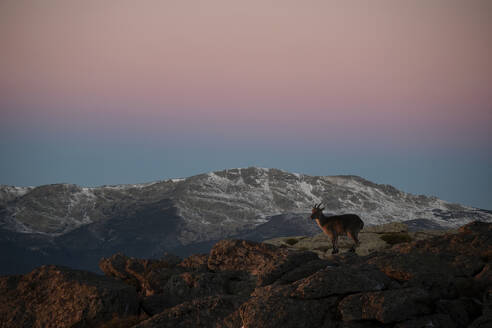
[367,223,492,299]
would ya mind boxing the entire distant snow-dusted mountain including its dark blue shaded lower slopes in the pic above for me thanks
[0,167,492,274]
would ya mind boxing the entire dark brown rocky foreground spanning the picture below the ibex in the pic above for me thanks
[0,222,492,328]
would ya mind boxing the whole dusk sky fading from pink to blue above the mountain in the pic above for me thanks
[0,0,492,209]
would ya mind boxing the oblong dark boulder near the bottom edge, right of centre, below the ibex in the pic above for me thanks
[338,288,431,324]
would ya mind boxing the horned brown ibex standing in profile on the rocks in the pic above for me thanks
[311,204,364,254]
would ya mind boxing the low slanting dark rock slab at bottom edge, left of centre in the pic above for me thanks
[133,295,244,328]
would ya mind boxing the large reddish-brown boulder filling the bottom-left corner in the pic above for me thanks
[0,266,138,328]
